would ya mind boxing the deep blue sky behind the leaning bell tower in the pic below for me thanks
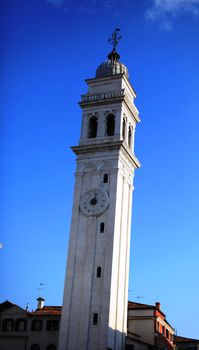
[0,0,199,338]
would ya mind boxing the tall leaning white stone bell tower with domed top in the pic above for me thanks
[59,29,140,350]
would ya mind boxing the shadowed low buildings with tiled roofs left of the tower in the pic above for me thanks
[0,301,61,350]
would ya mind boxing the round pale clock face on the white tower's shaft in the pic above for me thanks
[80,189,108,216]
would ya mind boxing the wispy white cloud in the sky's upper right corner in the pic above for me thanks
[146,0,199,30]
